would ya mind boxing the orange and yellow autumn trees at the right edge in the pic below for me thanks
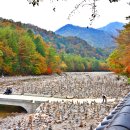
[108,23,130,76]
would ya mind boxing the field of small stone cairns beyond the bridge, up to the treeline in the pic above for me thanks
[0,72,129,99]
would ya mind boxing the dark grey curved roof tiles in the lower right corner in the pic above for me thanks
[95,93,130,130]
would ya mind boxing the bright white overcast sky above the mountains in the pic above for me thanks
[0,0,130,31]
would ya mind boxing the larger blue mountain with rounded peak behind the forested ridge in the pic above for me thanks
[55,24,116,48]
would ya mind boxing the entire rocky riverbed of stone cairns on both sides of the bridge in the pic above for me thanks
[0,72,130,130]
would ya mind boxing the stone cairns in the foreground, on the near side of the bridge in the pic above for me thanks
[0,101,116,130]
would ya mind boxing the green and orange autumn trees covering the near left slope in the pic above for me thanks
[0,21,61,75]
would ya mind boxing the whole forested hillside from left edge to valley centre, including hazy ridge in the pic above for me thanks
[0,18,108,75]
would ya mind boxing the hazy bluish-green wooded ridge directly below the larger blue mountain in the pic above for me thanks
[23,24,109,59]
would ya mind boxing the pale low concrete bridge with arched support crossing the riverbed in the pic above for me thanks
[0,94,115,113]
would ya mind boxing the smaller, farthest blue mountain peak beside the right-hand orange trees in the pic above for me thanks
[98,22,125,37]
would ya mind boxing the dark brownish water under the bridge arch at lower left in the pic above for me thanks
[0,105,27,118]
